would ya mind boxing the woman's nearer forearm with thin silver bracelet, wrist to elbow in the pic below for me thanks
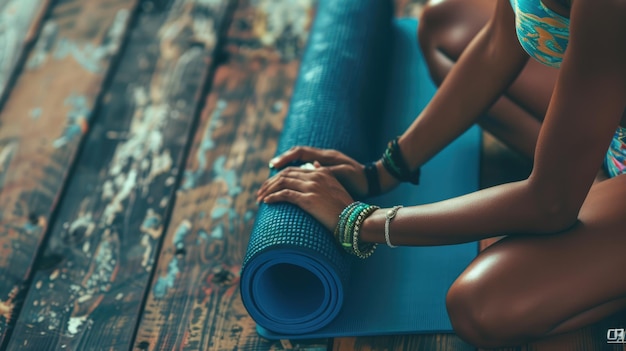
[360,180,576,246]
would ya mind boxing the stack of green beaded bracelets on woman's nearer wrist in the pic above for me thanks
[335,201,379,258]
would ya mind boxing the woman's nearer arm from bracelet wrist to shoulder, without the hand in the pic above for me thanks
[361,0,626,245]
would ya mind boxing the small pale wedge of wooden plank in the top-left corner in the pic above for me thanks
[0,0,50,106]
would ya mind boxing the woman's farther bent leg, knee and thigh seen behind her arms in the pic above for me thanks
[418,0,557,158]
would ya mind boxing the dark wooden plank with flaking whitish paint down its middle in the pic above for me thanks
[3,0,229,351]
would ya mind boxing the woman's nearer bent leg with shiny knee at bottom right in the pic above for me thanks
[447,176,626,347]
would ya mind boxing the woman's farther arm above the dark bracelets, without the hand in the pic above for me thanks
[378,0,528,188]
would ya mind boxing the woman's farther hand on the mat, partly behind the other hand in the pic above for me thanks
[270,146,380,198]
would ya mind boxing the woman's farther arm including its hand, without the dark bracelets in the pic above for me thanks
[266,0,528,197]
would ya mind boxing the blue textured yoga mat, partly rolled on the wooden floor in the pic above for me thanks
[241,0,480,339]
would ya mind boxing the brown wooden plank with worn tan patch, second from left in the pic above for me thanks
[0,0,134,345]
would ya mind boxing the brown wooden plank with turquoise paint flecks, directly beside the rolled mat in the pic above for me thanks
[135,0,327,351]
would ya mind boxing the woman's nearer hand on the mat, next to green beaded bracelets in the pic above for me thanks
[257,163,354,232]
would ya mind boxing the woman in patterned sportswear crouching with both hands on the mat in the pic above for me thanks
[258,0,626,347]
